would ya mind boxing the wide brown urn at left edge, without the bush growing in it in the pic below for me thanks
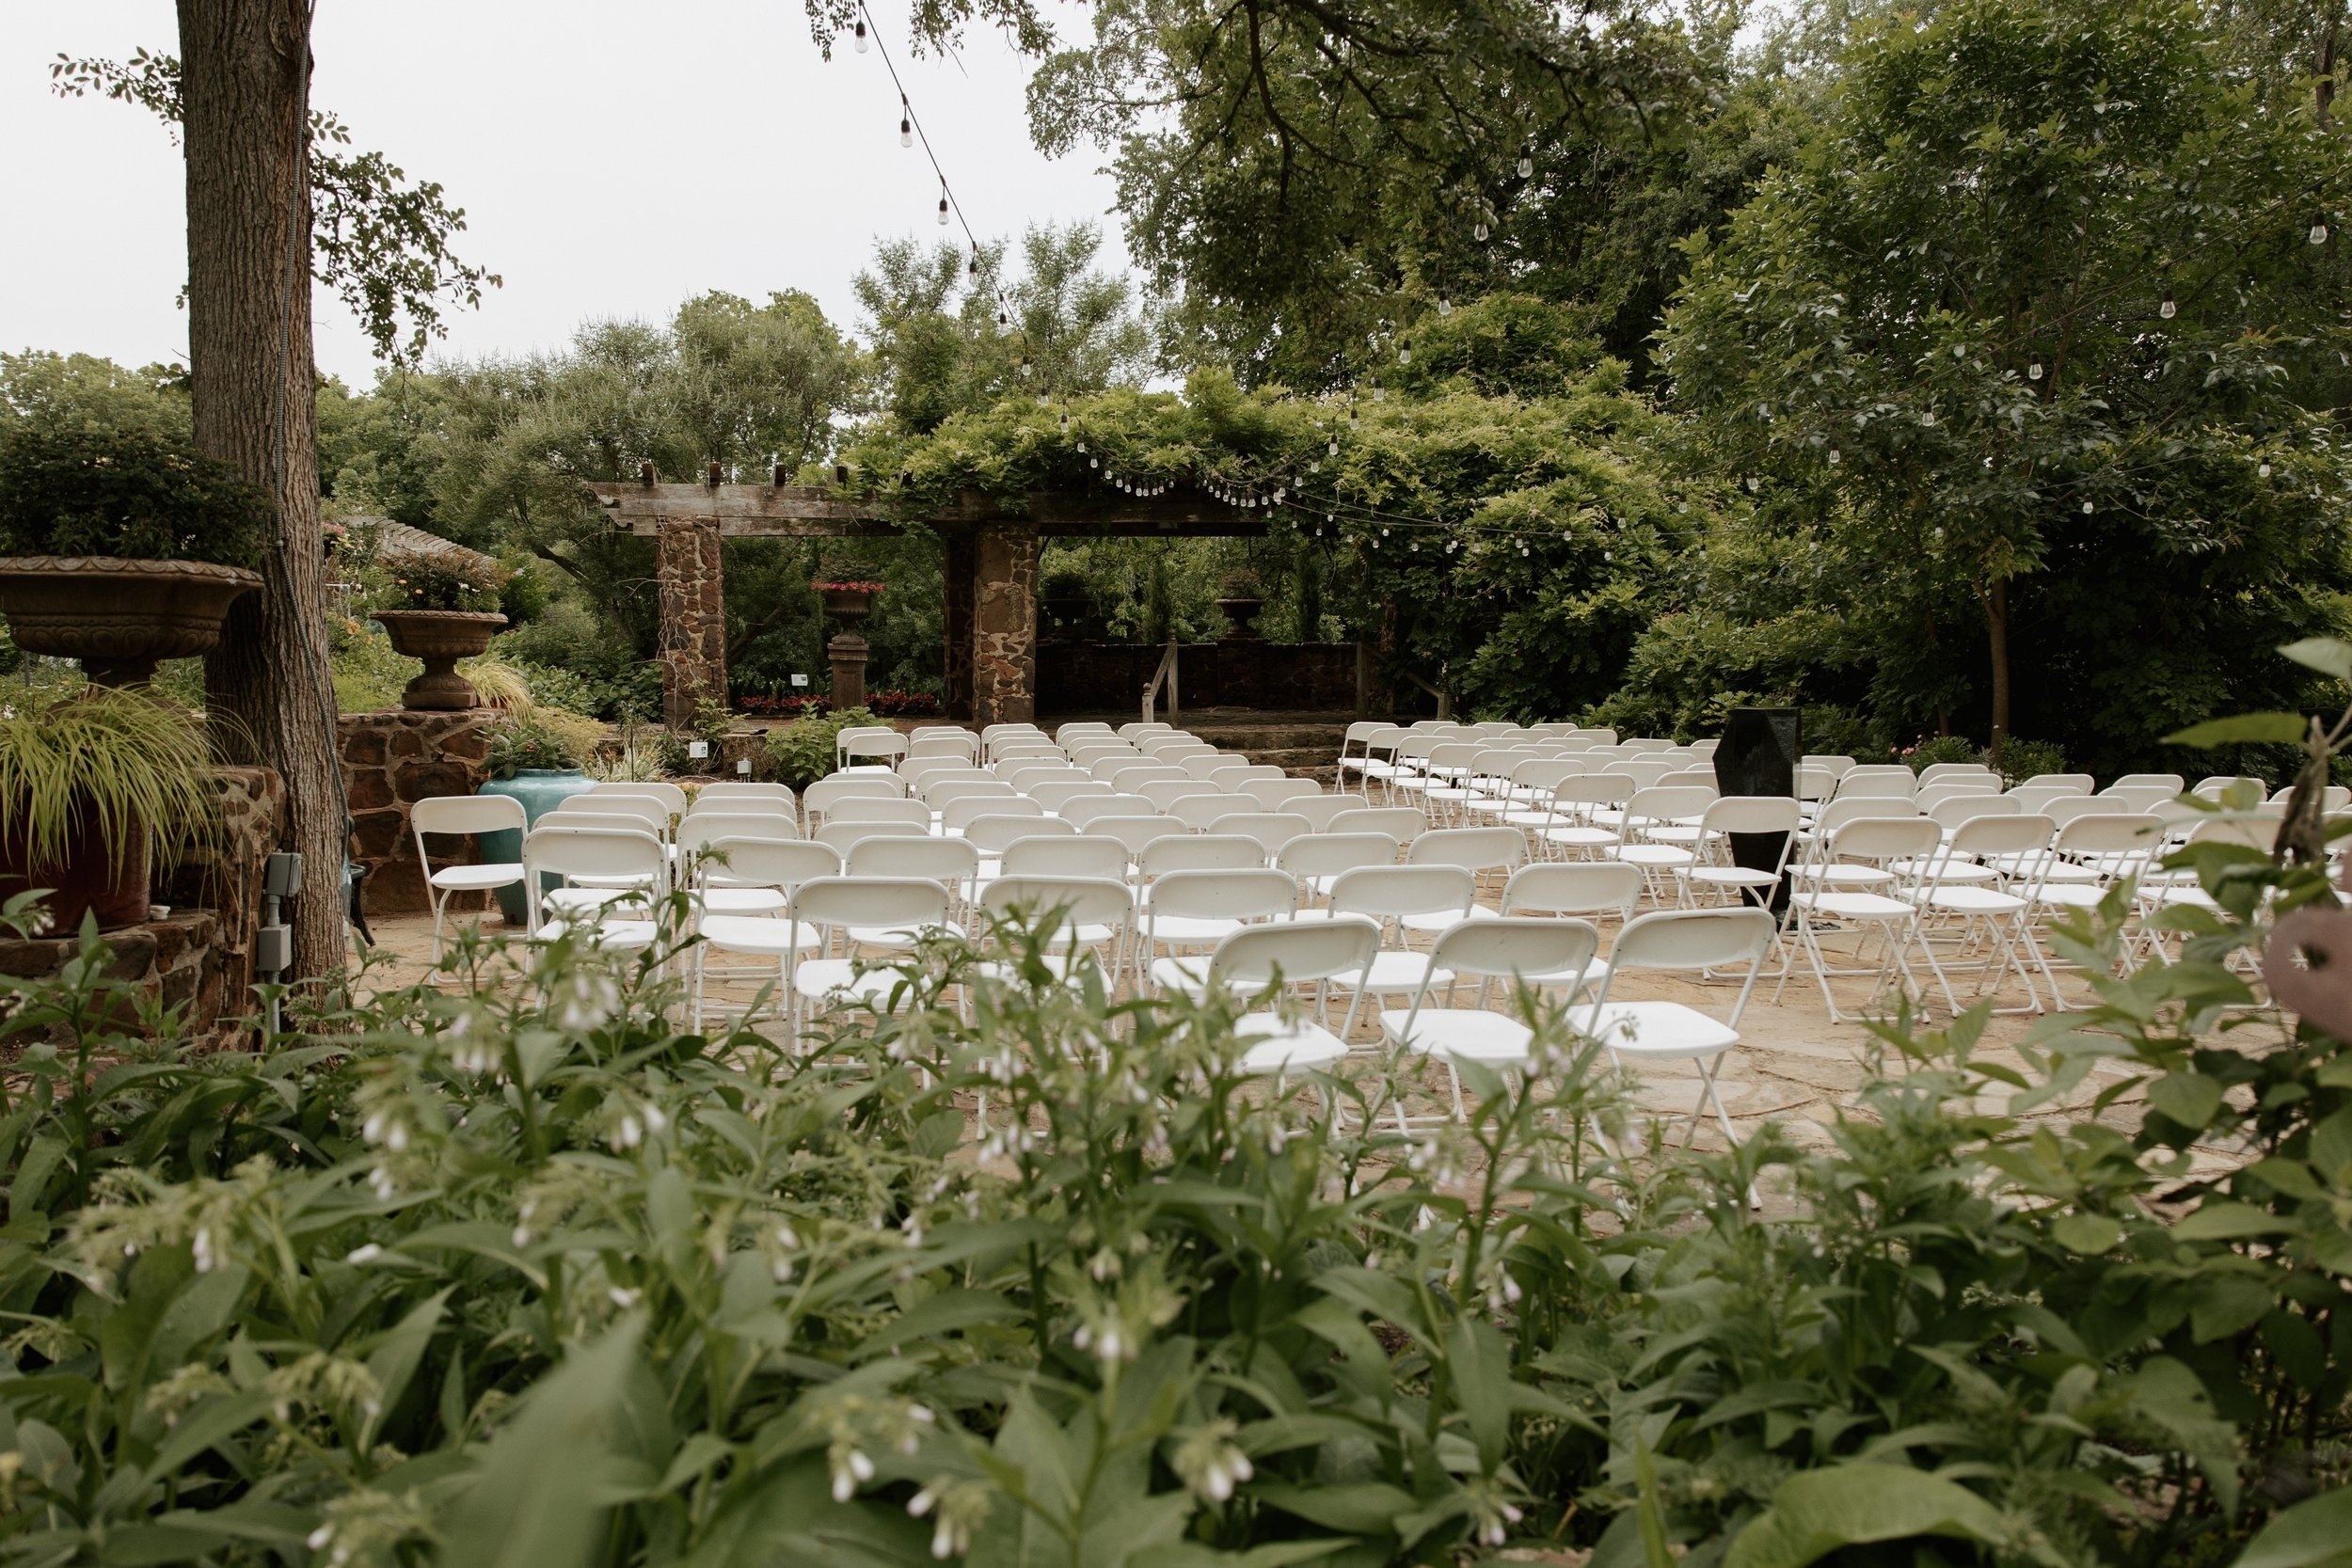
[0,555,262,687]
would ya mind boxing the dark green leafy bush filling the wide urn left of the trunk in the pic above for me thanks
[0,420,278,566]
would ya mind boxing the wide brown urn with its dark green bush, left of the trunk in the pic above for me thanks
[0,423,271,687]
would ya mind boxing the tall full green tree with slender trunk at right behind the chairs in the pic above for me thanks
[1663,0,2352,743]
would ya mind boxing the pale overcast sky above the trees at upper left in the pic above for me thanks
[0,0,1127,388]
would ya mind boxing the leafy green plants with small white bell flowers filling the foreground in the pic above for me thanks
[0,822,2352,1568]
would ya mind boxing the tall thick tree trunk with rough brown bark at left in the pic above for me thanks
[179,0,348,978]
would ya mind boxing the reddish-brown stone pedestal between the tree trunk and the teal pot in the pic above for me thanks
[337,707,499,914]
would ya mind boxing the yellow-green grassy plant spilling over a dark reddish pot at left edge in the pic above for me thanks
[0,687,221,931]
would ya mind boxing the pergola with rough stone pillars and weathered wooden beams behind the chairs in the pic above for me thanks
[588,463,1265,724]
